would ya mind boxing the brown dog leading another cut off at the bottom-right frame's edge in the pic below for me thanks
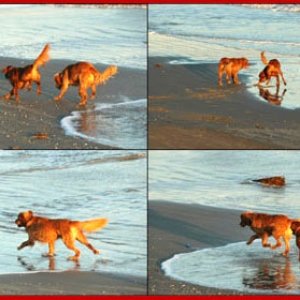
[240,211,292,256]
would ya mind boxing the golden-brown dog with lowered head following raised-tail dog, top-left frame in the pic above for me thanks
[54,62,118,106]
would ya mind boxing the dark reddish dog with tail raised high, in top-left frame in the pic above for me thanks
[2,44,50,101]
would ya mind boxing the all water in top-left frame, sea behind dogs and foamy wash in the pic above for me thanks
[0,5,147,149]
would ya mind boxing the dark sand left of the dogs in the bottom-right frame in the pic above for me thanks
[148,201,251,295]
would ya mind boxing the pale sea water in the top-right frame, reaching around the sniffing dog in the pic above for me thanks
[149,5,300,109]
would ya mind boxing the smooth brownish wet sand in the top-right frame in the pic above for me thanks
[149,57,300,149]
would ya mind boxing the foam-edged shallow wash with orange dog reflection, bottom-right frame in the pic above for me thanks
[162,240,300,295]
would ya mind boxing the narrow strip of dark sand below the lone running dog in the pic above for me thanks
[0,271,147,295]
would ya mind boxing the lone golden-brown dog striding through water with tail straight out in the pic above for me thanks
[15,210,108,260]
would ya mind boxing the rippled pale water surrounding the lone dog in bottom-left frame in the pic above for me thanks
[0,151,147,277]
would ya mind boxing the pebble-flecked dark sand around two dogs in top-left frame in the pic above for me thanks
[0,57,146,149]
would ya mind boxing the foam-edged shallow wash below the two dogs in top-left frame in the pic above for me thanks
[61,98,147,149]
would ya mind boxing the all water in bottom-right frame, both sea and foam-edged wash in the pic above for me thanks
[149,151,300,294]
